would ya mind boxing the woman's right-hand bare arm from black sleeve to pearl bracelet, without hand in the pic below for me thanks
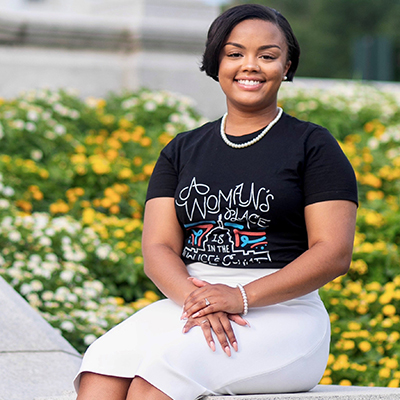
[245,201,357,307]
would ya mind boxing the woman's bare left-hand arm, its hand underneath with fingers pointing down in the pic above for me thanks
[142,197,246,355]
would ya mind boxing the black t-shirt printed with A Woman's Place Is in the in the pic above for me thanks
[147,113,357,268]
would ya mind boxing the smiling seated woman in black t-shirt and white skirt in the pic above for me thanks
[76,5,357,400]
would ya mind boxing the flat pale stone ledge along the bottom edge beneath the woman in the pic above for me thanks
[34,385,400,400]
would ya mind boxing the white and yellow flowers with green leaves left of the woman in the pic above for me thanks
[0,89,201,350]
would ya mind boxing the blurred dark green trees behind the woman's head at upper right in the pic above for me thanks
[225,0,400,81]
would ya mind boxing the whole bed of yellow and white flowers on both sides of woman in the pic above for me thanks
[0,84,400,387]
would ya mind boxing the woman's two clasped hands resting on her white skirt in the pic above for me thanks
[181,277,250,357]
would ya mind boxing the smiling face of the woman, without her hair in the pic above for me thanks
[218,19,290,112]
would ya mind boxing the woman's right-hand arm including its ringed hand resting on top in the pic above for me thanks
[184,200,357,317]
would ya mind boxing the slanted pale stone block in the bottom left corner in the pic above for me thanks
[0,277,81,400]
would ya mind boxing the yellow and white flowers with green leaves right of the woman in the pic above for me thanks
[280,85,400,387]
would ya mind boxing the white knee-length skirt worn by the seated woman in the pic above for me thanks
[74,263,330,400]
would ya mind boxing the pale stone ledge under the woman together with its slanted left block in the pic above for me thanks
[0,277,400,400]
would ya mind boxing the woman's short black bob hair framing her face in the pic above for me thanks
[200,4,300,81]
